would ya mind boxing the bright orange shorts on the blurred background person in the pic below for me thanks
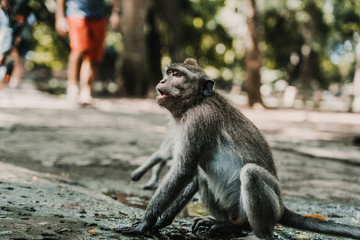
[67,17,107,62]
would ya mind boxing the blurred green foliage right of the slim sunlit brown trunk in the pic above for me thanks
[259,0,360,88]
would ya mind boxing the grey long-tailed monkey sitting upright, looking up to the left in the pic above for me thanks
[114,58,360,239]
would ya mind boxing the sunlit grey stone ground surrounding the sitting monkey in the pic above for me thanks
[0,80,360,239]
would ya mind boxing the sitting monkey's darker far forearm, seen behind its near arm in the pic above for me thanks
[155,177,199,228]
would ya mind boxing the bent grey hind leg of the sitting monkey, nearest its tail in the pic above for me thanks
[240,163,283,239]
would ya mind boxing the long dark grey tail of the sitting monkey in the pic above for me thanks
[279,207,360,239]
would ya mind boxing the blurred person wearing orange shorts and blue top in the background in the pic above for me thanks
[55,0,120,105]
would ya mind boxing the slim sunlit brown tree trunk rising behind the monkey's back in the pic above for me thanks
[244,0,263,107]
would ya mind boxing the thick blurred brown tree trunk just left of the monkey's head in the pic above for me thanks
[118,0,160,97]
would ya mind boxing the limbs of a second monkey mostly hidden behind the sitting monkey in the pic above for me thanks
[131,136,172,190]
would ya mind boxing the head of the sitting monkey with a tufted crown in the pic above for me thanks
[156,58,214,112]
